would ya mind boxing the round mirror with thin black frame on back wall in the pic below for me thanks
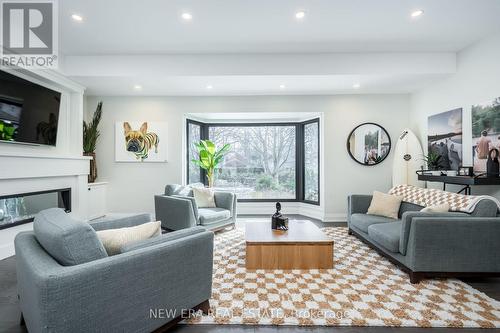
[347,123,391,166]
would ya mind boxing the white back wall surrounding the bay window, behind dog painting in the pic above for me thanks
[86,95,410,220]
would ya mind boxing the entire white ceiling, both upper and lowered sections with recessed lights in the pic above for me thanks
[59,0,500,95]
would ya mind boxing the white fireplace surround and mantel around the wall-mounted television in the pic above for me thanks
[0,70,89,259]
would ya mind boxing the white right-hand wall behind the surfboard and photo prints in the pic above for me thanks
[410,33,500,196]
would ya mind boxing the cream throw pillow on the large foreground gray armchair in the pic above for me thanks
[96,221,161,256]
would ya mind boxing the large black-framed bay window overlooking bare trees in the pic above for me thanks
[186,119,319,204]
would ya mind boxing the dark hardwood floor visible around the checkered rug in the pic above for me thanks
[0,216,500,333]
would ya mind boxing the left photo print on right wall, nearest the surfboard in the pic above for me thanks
[427,108,463,170]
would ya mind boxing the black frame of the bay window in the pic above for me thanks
[186,118,321,206]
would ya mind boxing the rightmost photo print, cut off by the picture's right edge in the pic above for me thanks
[471,97,500,173]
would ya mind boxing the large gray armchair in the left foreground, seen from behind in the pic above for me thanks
[15,209,213,333]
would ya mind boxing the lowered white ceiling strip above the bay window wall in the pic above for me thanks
[78,74,445,96]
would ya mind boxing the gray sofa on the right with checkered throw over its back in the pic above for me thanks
[347,195,500,283]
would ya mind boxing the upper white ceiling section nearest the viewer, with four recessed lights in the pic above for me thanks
[59,0,500,54]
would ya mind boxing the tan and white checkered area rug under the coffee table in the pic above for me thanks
[185,227,500,328]
